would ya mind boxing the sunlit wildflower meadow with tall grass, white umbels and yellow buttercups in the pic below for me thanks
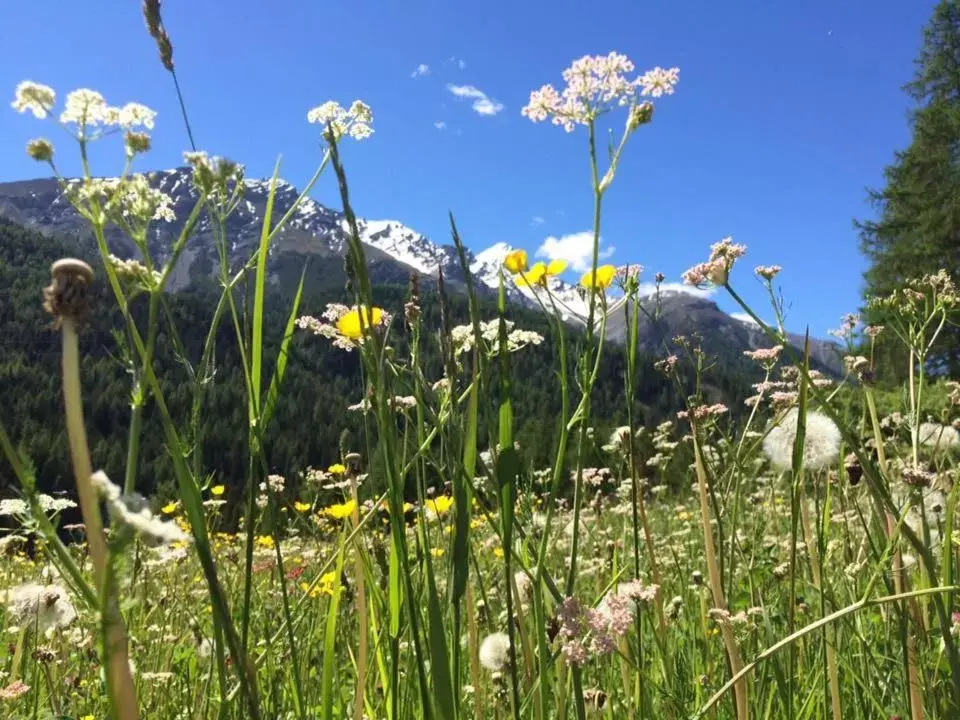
[0,21,960,720]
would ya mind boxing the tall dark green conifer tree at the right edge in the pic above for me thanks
[857,0,960,377]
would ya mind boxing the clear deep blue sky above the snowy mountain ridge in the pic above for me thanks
[0,0,933,335]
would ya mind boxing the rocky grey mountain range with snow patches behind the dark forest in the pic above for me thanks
[0,168,838,367]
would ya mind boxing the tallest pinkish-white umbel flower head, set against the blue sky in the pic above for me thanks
[521,52,679,132]
